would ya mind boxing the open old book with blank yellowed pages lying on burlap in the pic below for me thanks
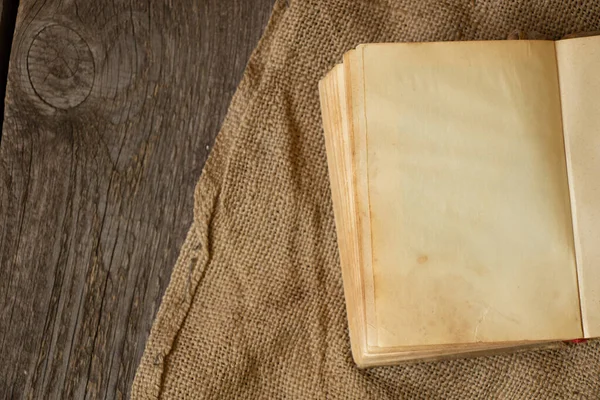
[319,36,600,366]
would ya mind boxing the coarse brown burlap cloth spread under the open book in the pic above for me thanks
[132,0,600,399]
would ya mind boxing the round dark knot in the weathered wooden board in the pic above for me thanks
[27,25,94,110]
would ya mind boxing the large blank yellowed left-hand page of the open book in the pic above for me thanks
[362,41,582,347]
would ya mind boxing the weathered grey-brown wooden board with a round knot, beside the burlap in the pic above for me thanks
[0,0,273,399]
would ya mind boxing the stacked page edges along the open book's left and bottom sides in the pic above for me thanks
[319,52,556,366]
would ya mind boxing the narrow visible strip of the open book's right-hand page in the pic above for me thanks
[556,36,600,337]
